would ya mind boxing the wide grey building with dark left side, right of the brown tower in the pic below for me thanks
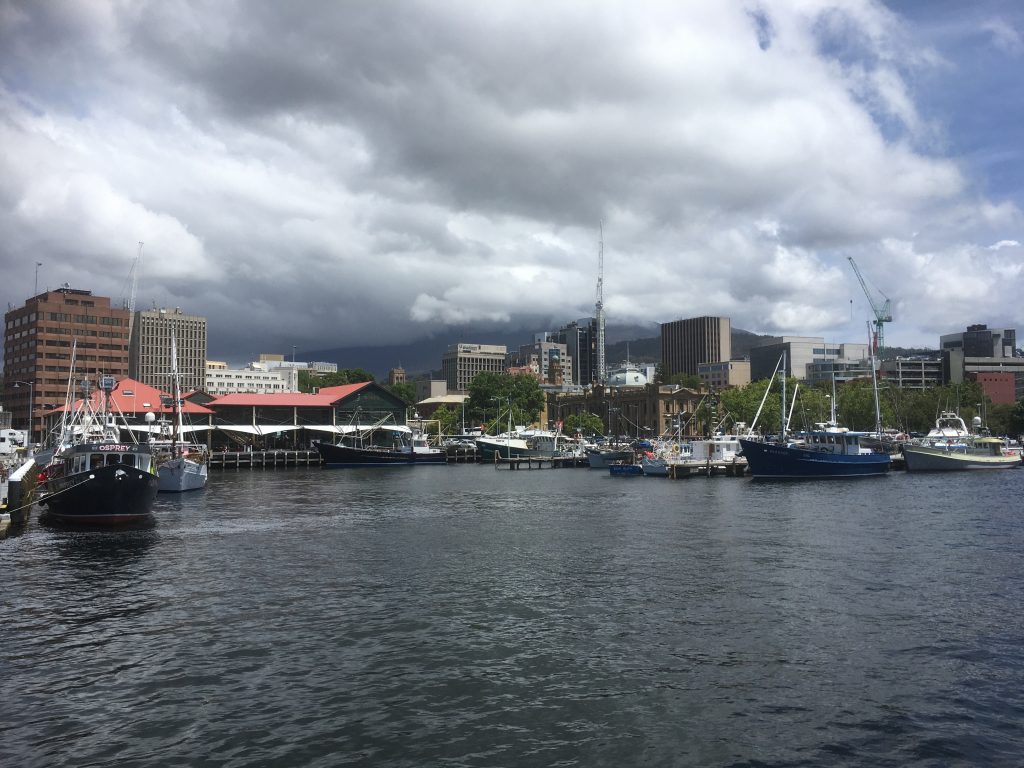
[751,336,871,382]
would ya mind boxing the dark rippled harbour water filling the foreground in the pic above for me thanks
[0,466,1024,766]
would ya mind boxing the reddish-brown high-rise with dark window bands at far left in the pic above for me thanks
[3,284,130,442]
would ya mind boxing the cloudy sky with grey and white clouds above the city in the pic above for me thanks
[0,0,1024,362]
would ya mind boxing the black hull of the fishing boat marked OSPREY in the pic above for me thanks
[40,465,158,525]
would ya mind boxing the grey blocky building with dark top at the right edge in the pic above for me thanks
[939,325,1024,403]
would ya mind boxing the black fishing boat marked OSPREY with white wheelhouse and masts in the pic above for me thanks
[39,376,158,525]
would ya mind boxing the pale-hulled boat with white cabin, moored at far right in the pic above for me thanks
[903,412,1021,472]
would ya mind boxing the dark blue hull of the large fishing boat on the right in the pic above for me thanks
[739,439,892,479]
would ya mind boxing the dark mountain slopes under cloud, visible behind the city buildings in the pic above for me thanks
[301,326,778,380]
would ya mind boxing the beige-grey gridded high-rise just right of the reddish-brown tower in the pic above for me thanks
[128,307,206,392]
